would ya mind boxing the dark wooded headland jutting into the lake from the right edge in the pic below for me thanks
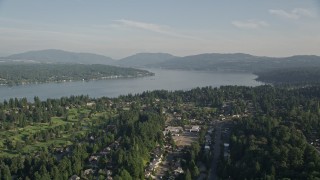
[256,67,320,85]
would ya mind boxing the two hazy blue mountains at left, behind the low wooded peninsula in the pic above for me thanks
[0,49,176,67]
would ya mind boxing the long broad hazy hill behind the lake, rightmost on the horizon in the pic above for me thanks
[152,53,320,73]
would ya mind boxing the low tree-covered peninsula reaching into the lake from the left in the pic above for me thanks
[0,64,153,85]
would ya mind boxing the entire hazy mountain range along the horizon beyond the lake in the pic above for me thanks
[0,49,320,73]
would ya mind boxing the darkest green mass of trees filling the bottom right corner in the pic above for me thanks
[219,116,320,179]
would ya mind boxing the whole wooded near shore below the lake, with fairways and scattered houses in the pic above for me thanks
[0,86,320,179]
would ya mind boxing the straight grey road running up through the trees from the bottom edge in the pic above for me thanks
[208,122,222,180]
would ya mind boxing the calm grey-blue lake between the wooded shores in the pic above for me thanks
[0,69,262,101]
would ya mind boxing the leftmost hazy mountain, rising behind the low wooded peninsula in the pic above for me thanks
[2,49,114,65]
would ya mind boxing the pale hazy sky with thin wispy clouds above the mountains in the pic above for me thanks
[0,0,320,58]
